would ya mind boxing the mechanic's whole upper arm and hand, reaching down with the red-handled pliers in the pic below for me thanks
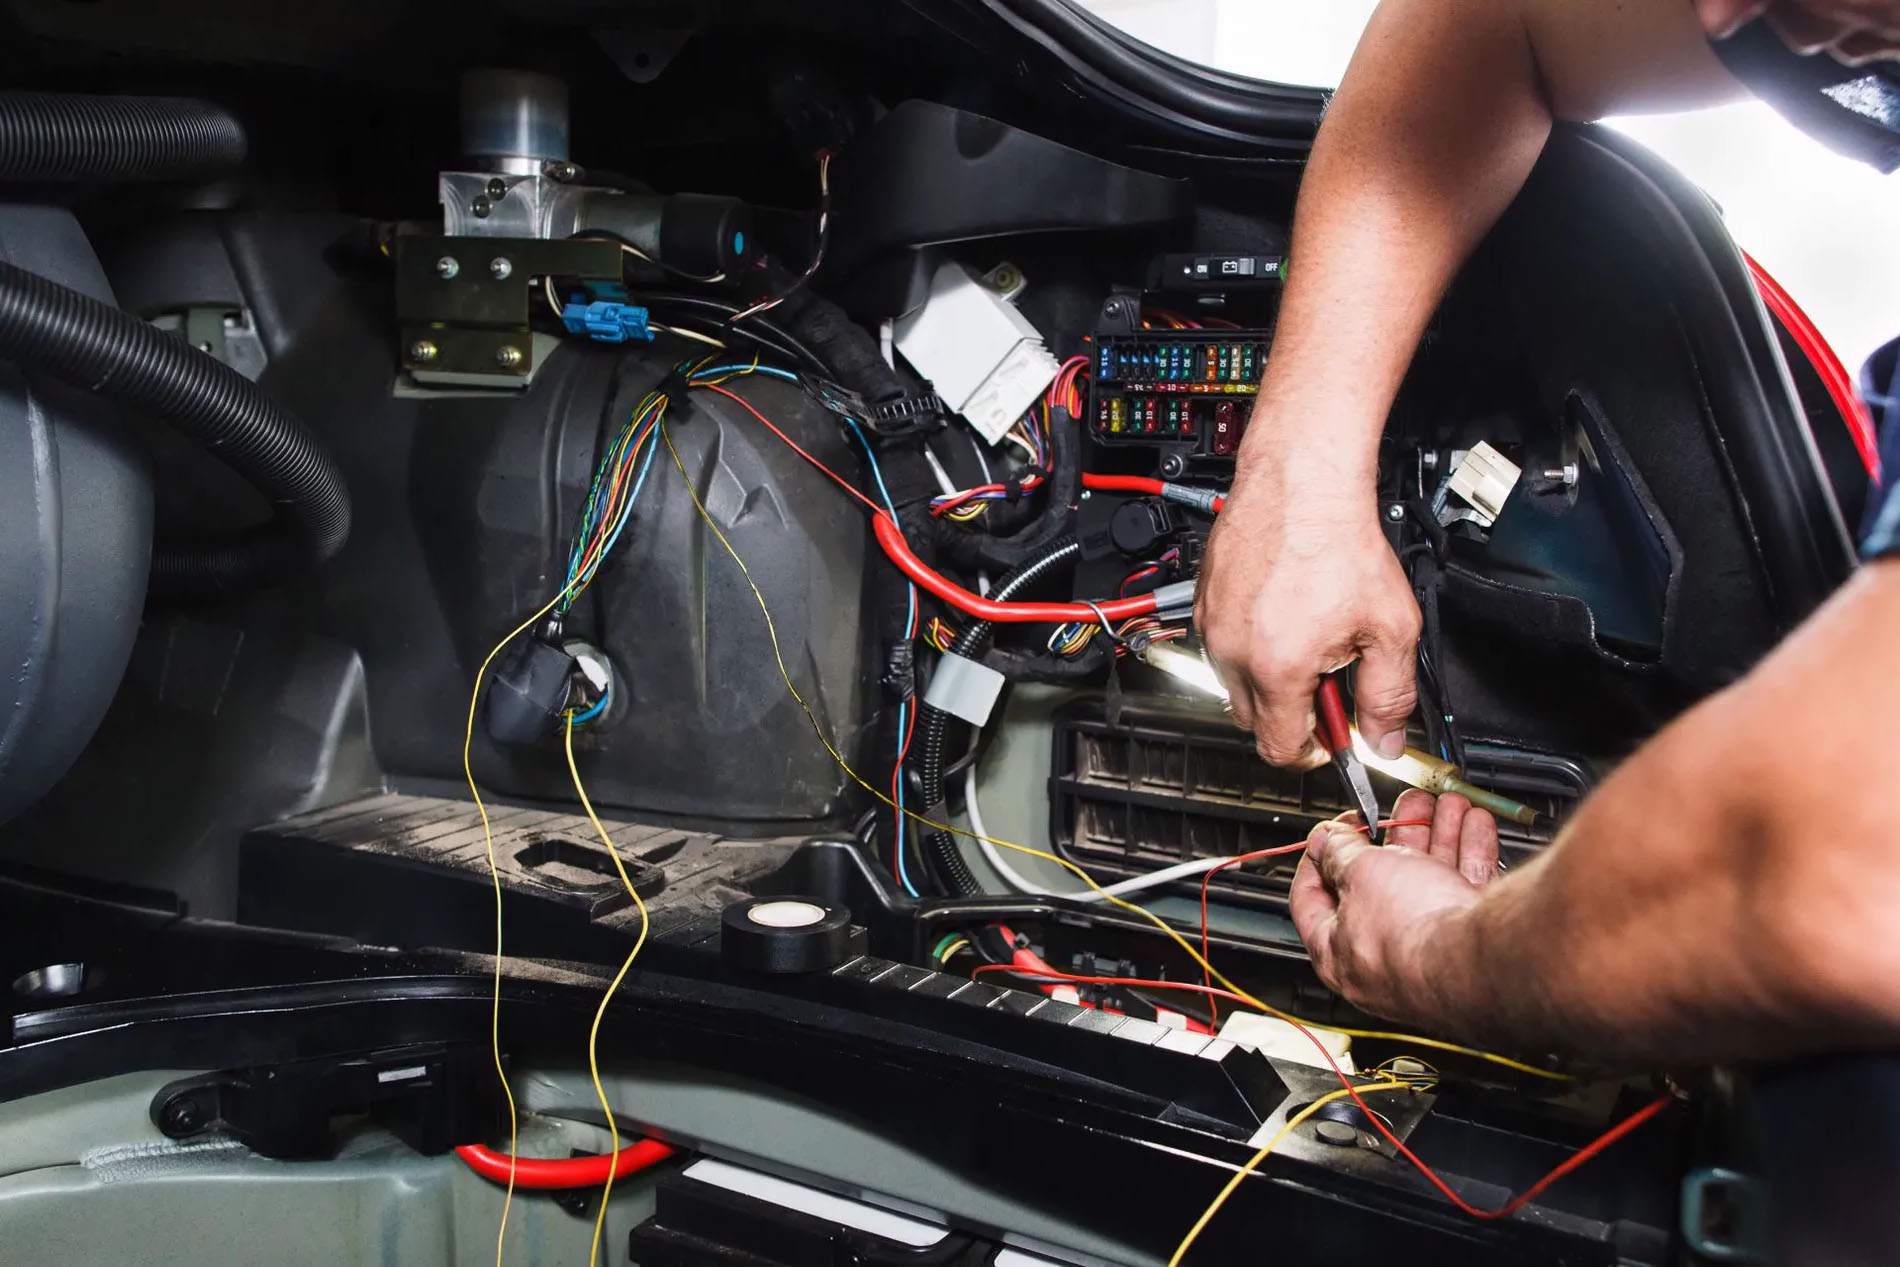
[1195,0,1740,764]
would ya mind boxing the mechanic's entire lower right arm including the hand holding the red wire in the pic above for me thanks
[1294,560,1900,1062]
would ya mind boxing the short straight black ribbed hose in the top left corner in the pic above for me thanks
[0,93,245,180]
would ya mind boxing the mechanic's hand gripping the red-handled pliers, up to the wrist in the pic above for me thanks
[1193,454,1419,766]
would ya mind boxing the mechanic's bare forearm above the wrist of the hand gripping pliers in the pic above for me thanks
[1241,0,1550,498]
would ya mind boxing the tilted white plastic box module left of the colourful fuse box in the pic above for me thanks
[893,264,1060,444]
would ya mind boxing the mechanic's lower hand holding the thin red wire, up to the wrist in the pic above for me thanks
[1290,790,1497,1020]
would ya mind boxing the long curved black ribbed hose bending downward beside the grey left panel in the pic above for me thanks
[0,262,350,596]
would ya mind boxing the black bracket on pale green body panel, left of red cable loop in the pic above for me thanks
[152,1043,496,1161]
